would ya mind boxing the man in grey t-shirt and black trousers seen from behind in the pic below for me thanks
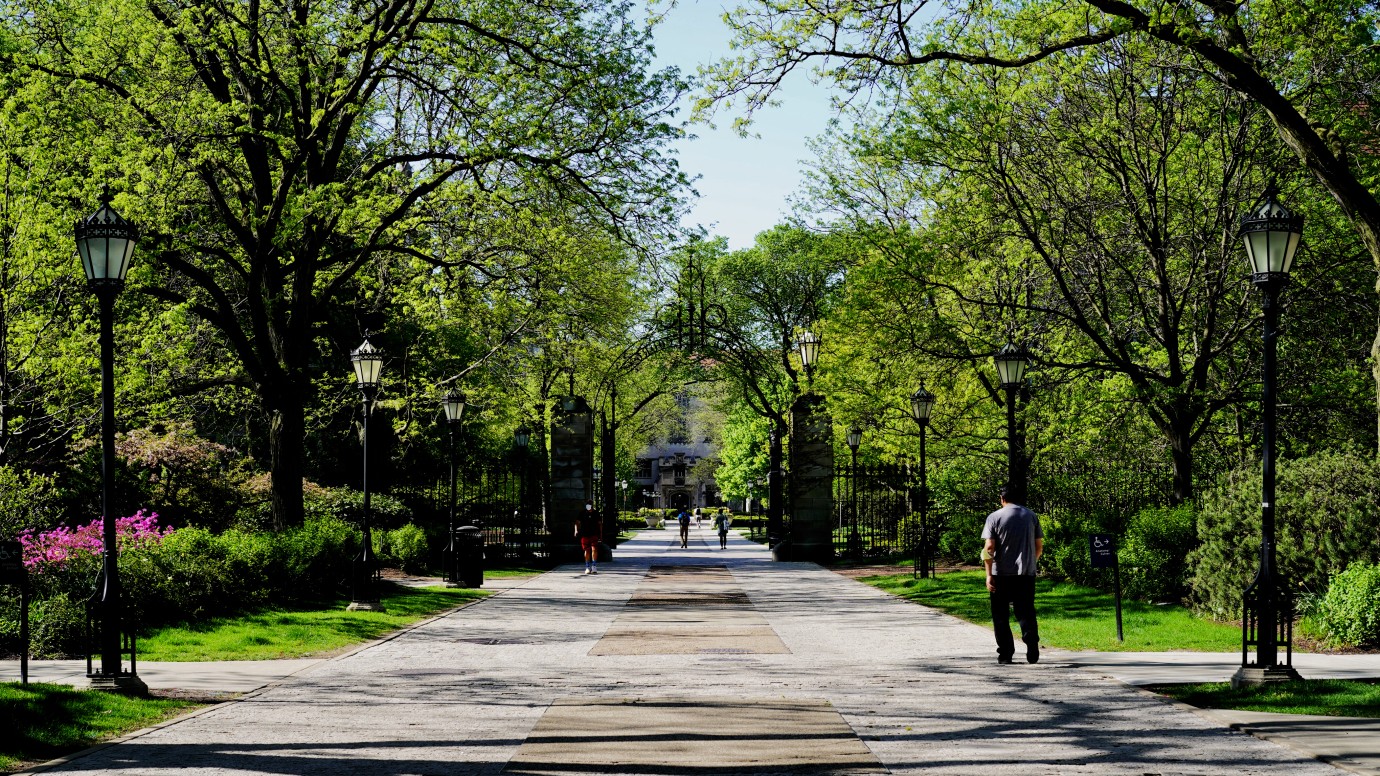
[983,487,1045,663]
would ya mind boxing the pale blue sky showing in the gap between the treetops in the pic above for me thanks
[657,0,832,249]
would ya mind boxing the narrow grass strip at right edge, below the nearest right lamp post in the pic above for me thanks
[1148,679,1380,717]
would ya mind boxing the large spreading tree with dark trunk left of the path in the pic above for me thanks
[4,0,680,525]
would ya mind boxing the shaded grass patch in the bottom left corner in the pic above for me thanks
[0,682,203,770]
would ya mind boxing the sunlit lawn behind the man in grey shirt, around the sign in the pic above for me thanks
[861,570,1241,652]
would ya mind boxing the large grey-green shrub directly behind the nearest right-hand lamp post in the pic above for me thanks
[1188,450,1380,619]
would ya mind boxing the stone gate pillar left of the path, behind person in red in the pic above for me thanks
[546,396,595,562]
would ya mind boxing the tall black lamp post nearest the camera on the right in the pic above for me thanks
[1231,185,1303,685]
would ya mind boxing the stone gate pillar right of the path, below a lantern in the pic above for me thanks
[787,394,834,563]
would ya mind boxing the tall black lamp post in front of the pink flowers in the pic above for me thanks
[75,188,148,693]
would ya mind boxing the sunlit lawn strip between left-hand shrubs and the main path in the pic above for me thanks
[139,585,489,661]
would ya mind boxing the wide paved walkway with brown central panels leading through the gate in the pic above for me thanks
[13,529,1380,776]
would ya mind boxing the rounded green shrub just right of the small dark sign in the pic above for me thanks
[1120,504,1198,601]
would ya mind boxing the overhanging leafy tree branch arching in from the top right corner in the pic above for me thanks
[701,0,1380,436]
